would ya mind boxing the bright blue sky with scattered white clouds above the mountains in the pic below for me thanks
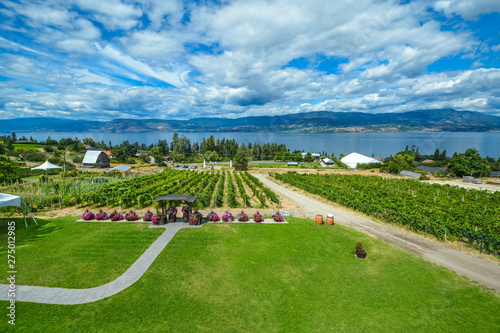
[0,0,500,120]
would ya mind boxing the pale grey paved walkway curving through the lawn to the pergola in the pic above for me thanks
[0,222,201,305]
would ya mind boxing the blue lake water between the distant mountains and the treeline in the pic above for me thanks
[6,132,500,159]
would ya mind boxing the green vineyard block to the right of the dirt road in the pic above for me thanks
[273,172,500,254]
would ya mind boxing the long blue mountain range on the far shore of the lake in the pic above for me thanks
[0,109,500,133]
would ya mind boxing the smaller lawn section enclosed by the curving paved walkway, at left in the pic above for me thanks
[0,217,161,288]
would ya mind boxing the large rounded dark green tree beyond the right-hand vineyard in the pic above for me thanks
[448,148,490,177]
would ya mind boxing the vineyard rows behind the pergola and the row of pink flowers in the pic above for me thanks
[0,169,279,211]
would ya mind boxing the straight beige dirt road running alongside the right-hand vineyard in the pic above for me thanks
[254,174,500,292]
